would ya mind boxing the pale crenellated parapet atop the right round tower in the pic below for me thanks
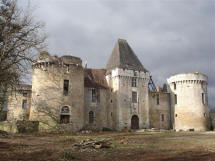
[167,72,208,84]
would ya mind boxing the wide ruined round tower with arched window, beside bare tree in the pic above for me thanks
[30,52,84,131]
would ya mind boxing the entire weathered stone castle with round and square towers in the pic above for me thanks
[7,39,209,131]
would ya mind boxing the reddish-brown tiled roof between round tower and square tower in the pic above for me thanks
[84,69,108,88]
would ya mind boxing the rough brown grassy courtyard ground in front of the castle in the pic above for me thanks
[0,131,215,161]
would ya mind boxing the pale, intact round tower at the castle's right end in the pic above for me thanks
[167,72,209,131]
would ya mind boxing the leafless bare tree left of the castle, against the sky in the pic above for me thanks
[0,0,46,113]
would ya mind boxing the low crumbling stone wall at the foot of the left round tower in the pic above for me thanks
[0,121,39,133]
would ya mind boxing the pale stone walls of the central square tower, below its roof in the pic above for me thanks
[106,68,149,130]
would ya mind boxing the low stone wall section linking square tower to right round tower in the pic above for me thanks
[149,92,171,129]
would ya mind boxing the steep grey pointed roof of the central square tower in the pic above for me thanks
[106,39,147,72]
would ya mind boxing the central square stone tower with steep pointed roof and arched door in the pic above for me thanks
[106,39,150,130]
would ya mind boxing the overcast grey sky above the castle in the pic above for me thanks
[20,0,215,105]
